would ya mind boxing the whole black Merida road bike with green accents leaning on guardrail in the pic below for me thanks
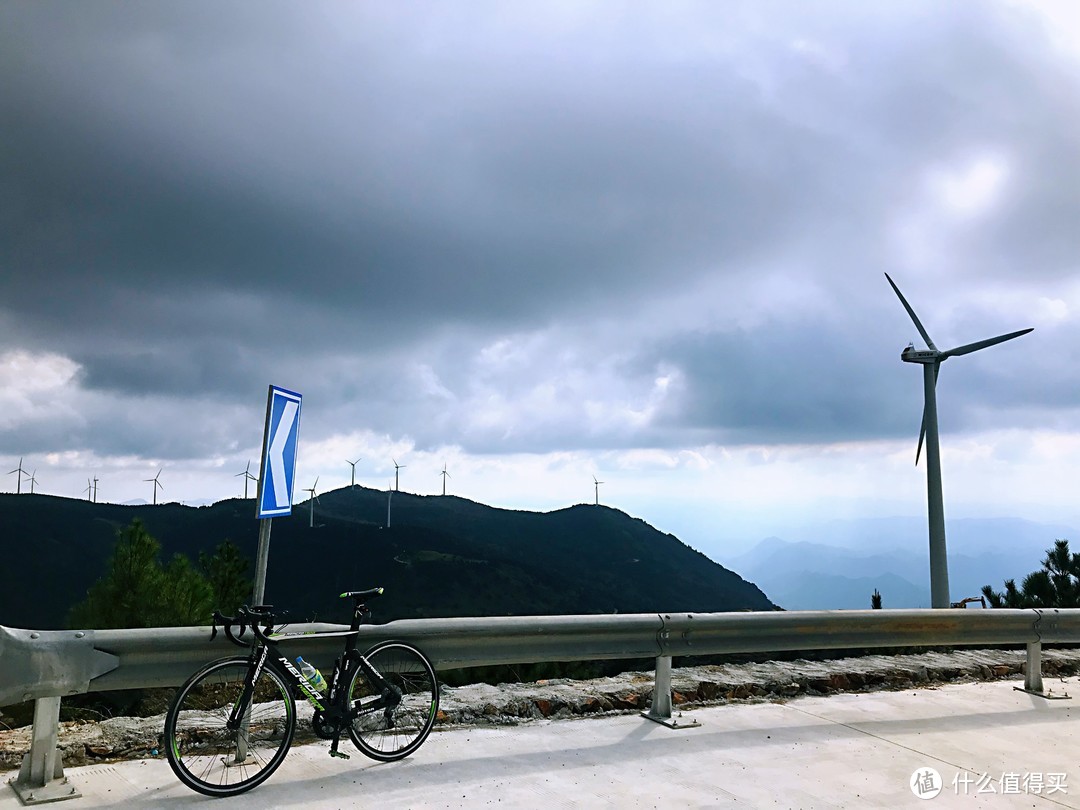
[164,588,438,796]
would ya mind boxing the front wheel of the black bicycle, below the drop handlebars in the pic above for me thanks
[164,657,296,796]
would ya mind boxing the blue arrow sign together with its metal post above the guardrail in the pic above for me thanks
[252,386,303,605]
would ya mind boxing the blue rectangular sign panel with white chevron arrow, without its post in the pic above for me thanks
[255,386,303,518]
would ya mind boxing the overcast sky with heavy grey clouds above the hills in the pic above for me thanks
[0,0,1080,558]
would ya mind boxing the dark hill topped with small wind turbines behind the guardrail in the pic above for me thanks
[0,486,774,630]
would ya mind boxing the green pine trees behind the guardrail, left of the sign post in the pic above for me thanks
[69,517,252,629]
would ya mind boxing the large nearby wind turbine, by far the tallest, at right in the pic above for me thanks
[885,273,1031,608]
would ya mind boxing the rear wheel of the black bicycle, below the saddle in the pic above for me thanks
[347,642,438,761]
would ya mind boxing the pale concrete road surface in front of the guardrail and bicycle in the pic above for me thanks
[0,680,1080,810]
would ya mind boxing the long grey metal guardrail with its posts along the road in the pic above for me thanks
[0,609,1080,804]
